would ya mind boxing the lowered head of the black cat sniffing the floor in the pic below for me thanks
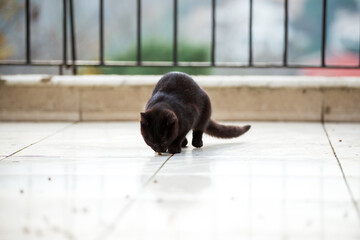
[140,109,178,153]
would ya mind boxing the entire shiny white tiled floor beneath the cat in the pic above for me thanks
[0,122,360,240]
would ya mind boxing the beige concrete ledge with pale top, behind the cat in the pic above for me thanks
[0,75,360,122]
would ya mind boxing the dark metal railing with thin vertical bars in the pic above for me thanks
[0,0,360,74]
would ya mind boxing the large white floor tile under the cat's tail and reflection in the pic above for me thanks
[105,123,360,239]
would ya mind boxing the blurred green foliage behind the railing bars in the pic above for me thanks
[79,41,211,75]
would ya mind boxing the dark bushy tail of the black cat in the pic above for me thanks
[205,119,251,138]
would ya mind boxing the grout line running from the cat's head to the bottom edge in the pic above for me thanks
[94,154,174,240]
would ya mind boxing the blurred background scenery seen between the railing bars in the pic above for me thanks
[0,0,360,76]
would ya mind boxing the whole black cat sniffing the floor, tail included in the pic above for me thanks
[140,72,250,153]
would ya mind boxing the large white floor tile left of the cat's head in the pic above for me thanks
[0,123,169,239]
